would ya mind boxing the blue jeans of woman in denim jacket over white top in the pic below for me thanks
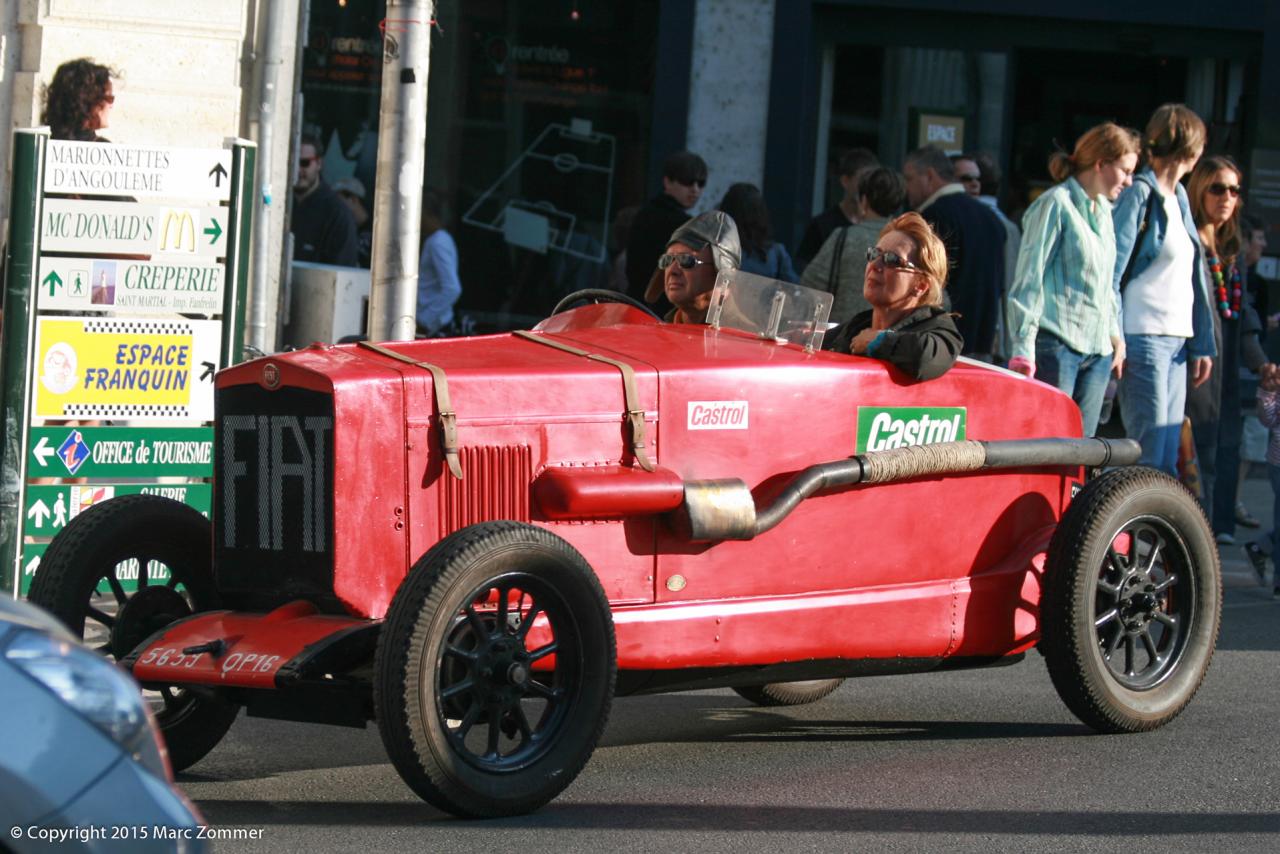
[1120,335,1187,478]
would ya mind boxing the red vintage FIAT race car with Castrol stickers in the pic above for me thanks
[31,275,1221,817]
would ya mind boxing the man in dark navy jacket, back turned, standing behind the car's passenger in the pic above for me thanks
[902,146,1005,360]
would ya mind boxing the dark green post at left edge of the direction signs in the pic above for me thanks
[0,128,49,594]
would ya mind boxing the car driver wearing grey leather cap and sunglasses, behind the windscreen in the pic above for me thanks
[644,210,742,323]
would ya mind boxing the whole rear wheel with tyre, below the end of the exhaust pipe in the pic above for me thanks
[1041,467,1222,732]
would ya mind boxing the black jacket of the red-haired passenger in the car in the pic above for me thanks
[822,306,964,379]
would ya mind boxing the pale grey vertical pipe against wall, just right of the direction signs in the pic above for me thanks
[248,0,289,352]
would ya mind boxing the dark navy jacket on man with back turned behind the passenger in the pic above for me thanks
[920,193,1005,353]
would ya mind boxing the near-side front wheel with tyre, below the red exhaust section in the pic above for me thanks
[374,522,617,818]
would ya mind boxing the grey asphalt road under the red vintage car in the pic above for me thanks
[179,558,1280,853]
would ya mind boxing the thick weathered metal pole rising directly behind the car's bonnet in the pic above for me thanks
[369,0,433,341]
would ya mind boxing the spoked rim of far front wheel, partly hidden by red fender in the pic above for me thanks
[82,548,196,727]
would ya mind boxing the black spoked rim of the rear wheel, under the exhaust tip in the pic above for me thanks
[1093,516,1199,691]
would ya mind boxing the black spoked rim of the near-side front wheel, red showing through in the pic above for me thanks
[435,572,584,773]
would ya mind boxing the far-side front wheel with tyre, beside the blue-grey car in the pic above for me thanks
[28,495,239,771]
